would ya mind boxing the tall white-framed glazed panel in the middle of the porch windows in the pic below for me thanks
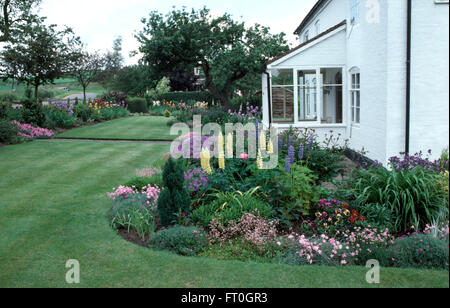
[297,70,317,121]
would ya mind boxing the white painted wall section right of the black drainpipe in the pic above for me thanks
[411,0,449,157]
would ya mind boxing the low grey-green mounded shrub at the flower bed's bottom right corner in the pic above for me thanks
[391,234,449,270]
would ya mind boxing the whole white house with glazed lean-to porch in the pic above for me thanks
[262,0,449,162]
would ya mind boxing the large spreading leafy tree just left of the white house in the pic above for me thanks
[136,8,288,106]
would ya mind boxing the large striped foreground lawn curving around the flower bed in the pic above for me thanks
[0,141,449,288]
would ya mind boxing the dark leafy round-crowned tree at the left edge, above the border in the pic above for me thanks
[0,22,79,100]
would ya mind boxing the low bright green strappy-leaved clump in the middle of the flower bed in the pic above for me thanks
[191,189,272,228]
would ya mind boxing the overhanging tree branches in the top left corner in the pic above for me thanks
[0,0,42,42]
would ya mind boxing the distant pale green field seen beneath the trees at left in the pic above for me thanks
[0,78,106,99]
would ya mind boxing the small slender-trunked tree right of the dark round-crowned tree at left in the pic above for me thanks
[70,48,105,103]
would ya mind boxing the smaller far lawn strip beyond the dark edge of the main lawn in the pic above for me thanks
[56,116,177,141]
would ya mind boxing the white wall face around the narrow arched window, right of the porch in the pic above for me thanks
[344,0,390,163]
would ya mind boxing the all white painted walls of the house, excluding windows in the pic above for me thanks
[263,0,449,163]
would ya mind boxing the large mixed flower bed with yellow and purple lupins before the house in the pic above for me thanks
[107,106,449,270]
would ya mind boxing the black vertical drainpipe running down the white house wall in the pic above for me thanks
[405,0,412,154]
